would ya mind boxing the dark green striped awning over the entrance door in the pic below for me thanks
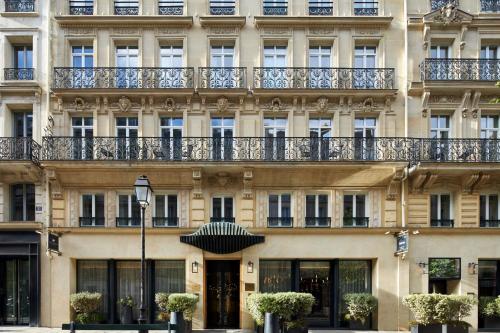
[181,222,264,254]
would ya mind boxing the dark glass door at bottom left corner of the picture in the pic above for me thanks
[0,259,30,325]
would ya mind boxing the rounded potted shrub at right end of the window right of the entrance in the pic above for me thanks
[344,293,378,329]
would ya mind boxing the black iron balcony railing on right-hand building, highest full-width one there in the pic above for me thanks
[420,58,500,81]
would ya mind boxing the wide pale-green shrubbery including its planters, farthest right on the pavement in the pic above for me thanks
[403,294,476,333]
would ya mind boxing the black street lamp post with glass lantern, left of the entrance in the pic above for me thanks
[134,176,153,330]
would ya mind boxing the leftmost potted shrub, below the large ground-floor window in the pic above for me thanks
[70,292,102,324]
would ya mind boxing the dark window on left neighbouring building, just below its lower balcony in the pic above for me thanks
[10,184,35,222]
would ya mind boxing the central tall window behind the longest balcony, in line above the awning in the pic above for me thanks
[211,117,234,160]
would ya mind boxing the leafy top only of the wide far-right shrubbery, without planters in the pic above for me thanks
[403,294,477,325]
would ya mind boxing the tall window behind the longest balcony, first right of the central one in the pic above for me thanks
[264,117,287,160]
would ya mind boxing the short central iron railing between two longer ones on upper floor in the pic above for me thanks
[198,67,247,89]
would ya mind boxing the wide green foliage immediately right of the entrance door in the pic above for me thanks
[247,292,315,329]
